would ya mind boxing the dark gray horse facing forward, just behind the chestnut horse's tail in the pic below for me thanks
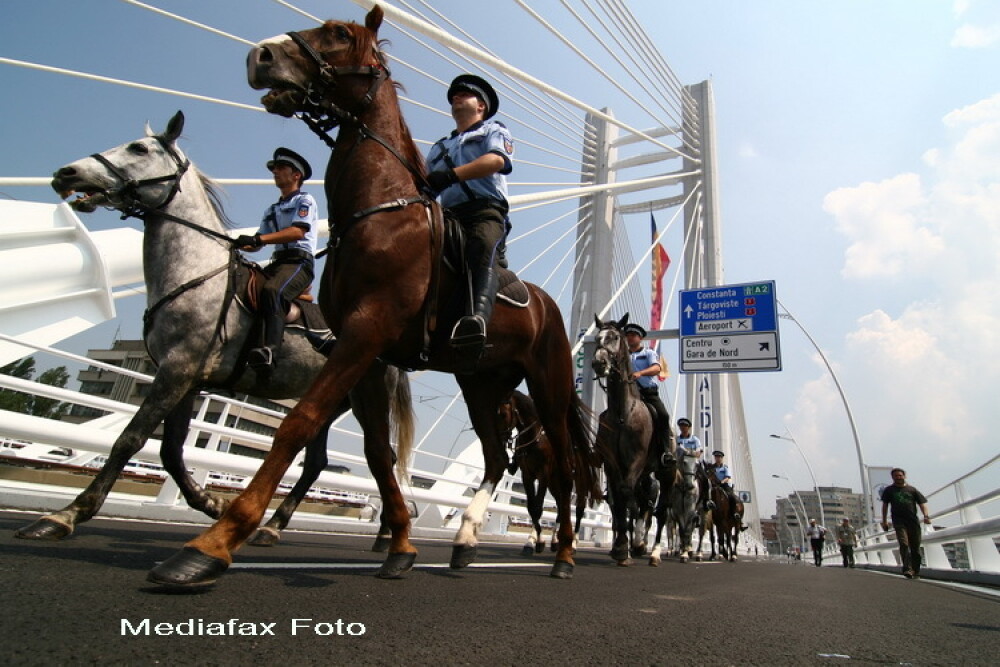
[591,313,668,566]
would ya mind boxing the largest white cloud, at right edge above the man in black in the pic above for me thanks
[816,95,1000,476]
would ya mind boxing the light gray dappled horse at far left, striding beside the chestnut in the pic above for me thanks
[16,112,413,543]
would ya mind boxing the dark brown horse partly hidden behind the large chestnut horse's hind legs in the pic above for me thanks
[500,391,599,556]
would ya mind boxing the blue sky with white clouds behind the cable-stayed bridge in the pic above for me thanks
[0,0,1000,516]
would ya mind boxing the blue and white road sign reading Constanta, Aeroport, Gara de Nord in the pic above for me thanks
[680,280,781,373]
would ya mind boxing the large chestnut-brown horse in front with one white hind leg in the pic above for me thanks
[149,6,596,587]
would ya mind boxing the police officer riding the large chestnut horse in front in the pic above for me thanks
[427,74,514,361]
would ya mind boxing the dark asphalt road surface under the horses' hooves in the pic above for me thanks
[0,511,1000,666]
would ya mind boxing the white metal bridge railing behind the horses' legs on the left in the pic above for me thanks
[0,336,611,542]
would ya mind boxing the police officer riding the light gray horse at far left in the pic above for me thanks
[235,147,317,369]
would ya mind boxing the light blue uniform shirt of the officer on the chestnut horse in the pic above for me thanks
[427,120,514,207]
